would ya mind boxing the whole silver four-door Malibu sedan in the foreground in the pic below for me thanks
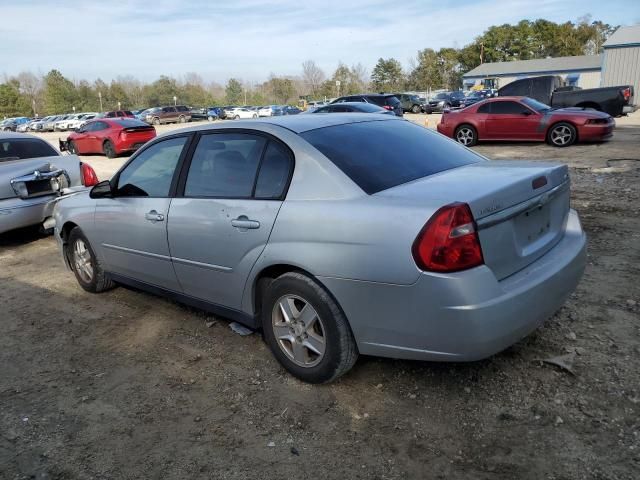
[55,113,586,383]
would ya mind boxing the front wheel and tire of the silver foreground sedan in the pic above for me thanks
[65,227,115,293]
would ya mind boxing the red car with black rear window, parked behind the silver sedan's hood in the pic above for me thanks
[61,118,156,158]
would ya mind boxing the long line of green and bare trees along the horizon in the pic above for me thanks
[0,16,616,116]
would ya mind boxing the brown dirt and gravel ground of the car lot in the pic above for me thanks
[0,115,640,480]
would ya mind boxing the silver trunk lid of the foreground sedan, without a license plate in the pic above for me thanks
[376,161,570,280]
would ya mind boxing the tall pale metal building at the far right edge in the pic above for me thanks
[602,25,640,104]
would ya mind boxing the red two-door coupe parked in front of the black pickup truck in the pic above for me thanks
[438,97,615,147]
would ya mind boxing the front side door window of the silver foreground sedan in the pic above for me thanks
[117,137,187,197]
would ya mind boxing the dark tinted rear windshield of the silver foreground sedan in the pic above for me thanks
[300,120,483,195]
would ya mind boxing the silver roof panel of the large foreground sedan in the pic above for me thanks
[159,113,400,137]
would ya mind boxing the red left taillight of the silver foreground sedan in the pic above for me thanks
[411,203,484,272]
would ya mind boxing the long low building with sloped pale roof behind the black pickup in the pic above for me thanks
[462,54,606,90]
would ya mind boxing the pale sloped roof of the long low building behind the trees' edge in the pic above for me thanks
[463,55,602,78]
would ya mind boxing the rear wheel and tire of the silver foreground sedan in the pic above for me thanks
[262,272,358,383]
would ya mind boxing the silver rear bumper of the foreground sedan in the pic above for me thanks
[319,211,586,361]
